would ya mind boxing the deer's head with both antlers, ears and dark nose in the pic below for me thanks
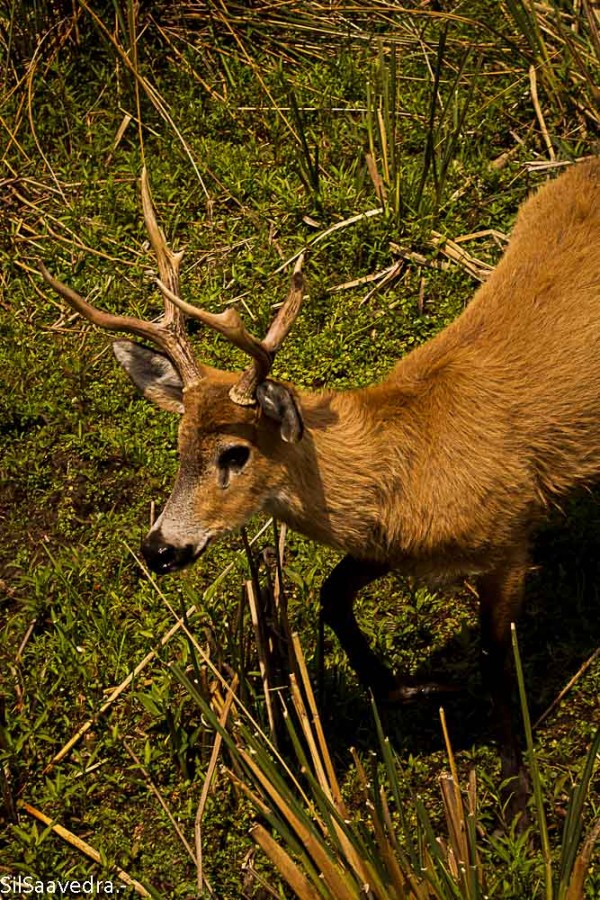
[40,170,303,573]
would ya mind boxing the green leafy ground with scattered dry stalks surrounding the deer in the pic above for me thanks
[0,0,600,898]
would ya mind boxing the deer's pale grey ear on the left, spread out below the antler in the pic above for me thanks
[113,341,183,414]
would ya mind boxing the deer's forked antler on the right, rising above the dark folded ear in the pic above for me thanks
[157,254,304,406]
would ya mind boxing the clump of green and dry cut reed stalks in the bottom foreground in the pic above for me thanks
[174,635,600,900]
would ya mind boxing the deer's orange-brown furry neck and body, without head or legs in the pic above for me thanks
[245,161,600,576]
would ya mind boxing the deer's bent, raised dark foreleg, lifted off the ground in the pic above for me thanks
[319,556,396,699]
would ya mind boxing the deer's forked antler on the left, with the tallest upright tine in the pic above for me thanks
[40,168,203,384]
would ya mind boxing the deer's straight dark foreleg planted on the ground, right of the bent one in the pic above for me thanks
[477,560,529,825]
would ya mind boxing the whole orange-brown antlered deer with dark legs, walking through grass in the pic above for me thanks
[41,159,600,809]
